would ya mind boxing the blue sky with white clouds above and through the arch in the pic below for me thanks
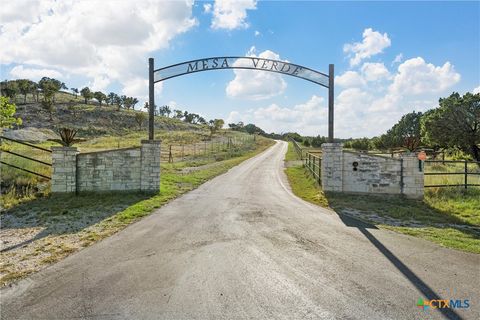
[0,0,480,138]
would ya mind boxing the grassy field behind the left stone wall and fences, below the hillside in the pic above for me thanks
[0,130,254,207]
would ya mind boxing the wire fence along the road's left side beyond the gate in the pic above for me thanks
[161,135,255,163]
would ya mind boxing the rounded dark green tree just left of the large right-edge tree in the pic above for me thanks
[385,111,422,151]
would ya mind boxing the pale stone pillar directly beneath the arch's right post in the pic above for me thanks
[322,143,343,192]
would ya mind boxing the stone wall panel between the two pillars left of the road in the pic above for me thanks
[77,148,141,191]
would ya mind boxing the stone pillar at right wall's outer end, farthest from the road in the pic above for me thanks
[401,153,424,199]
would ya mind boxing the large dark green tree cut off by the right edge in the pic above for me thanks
[421,92,480,161]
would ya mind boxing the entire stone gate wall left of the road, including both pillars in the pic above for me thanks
[52,140,160,193]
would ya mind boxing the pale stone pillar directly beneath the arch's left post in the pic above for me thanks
[140,140,161,192]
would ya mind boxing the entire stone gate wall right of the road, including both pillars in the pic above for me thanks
[322,143,424,199]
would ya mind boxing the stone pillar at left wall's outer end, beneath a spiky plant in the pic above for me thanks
[52,147,78,193]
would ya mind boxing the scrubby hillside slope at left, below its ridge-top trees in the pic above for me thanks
[3,93,205,142]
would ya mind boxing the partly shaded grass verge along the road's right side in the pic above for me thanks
[285,141,480,253]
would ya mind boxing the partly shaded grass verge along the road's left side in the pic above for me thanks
[0,138,273,285]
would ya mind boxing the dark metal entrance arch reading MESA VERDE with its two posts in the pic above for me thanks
[148,57,334,142]
